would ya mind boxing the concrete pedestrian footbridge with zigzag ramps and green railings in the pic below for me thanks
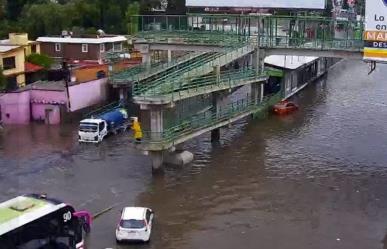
[110,15,364,168]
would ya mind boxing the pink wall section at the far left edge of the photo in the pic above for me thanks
[0,91,30,124]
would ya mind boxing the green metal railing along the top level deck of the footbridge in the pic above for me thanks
[129,14,364,51]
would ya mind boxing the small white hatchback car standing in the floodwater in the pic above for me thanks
[116,207,154,242]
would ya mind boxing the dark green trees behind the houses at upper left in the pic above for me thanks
[0,0,177,39]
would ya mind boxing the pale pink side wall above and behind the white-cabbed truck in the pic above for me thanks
[69,78,108,112]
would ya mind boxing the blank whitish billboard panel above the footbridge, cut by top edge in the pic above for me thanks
[186,0,325,9]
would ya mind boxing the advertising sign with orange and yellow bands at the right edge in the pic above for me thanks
[364,0,387,62]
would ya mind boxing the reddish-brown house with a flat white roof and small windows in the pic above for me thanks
[37,36,127,63]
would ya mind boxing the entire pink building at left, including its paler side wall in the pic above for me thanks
[0,78,107,124]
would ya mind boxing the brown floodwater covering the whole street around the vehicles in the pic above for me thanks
[0,61,387,249]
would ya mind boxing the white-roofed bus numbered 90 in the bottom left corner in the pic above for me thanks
[0,194,91,249]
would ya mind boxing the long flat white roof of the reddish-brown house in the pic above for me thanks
[36,36,127,44]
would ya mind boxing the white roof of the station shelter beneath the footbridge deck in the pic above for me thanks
[265,55,318,69]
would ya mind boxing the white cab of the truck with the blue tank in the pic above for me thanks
[78,119,108,143]
